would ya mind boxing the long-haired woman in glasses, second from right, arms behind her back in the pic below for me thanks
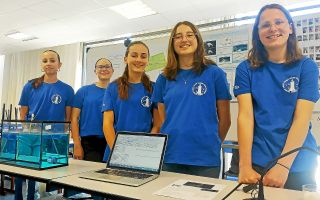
[152,21,231,177]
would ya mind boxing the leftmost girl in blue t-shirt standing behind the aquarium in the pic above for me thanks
[15,50,74,199]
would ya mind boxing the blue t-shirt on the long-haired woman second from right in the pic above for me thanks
[152,65,231,166]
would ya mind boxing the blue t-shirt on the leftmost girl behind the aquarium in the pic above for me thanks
[19,80,74,121]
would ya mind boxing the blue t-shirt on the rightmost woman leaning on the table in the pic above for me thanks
[234,58,319,172]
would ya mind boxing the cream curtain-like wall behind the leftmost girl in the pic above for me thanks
[1,43,82,106]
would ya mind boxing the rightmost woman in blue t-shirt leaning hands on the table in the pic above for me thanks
[234,4,319,190]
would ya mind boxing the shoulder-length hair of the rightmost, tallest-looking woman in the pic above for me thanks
[248,4,302,67]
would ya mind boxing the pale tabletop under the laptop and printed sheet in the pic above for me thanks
[49,172,320,200]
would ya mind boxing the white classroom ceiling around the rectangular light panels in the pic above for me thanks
[0,0,301,55]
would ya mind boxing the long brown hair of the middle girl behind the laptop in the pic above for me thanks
[116,41,152,100]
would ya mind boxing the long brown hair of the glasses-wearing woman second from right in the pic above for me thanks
[163,21,215,80]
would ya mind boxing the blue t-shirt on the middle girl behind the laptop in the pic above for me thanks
[102,82,154,161]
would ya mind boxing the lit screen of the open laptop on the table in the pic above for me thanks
[108,132,167,172]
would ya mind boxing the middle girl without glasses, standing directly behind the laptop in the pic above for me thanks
[102,41,159,161]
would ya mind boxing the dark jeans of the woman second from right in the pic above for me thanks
[162,163,220,178]
